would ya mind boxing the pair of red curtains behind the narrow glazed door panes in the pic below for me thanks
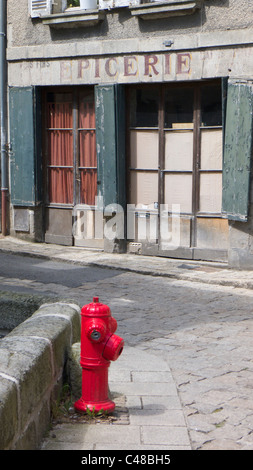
[47,93,97,205]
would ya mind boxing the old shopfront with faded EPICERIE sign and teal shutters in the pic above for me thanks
[4,1,253,268]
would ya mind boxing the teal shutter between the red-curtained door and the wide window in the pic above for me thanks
[95,84,125,207]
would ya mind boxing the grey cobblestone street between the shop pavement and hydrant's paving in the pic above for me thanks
[0,248,253,450]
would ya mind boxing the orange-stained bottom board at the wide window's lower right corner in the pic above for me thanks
[197,217,228,250]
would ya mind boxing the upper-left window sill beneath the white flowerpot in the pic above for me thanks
[41,8,105,28]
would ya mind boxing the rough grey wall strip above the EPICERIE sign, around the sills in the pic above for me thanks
[8,0,253,47]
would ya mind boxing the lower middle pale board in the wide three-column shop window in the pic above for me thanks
[164,174,192,213]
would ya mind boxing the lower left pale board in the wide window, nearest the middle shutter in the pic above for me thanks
[130,171,158,207]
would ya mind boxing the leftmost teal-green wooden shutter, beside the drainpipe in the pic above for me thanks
[9,87,41,206]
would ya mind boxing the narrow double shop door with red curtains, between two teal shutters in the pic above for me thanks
[43,87,97,245]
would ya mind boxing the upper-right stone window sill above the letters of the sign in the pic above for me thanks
[129,0,201,20]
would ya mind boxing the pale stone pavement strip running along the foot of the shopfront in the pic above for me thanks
[0,237,253,289]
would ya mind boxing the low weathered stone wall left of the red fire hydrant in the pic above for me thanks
[0,302,80,450]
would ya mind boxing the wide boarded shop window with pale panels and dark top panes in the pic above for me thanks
[127,81,228,261]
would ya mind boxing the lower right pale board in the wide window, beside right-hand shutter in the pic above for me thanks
[200,173,222,213]
